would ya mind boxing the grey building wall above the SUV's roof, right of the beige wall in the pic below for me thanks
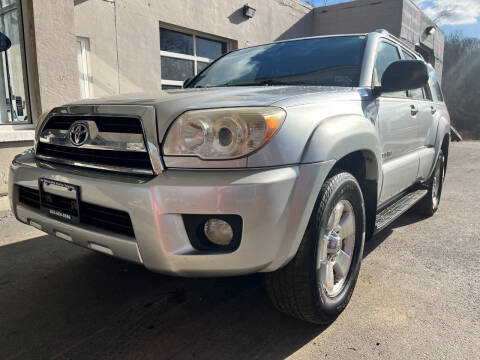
[313,0,403,36]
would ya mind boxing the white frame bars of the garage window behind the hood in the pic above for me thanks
[160,25,231,87]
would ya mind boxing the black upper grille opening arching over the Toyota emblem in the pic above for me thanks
[43,115,143,134]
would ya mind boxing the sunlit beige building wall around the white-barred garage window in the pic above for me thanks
[74,0,313,96]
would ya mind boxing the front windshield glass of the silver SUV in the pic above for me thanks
[188,36,365,88]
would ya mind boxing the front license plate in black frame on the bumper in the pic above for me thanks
[38,179,80,224]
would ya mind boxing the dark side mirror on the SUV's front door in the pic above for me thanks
[375,60,428,96]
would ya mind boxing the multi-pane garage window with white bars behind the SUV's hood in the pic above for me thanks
[160,28,227,90]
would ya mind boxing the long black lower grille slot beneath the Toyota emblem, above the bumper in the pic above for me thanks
[37,142,152,171]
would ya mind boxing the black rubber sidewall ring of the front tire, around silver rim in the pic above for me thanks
[313,175,365,316]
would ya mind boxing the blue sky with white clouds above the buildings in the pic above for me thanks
[308,0,480,38]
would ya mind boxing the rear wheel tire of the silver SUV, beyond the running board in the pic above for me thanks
[414,150,445,217]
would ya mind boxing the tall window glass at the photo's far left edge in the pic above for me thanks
[0,0,31,125]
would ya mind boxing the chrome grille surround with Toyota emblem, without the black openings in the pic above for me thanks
[35,105,164,175]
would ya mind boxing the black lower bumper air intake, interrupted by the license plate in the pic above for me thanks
[18,186,135,237]
